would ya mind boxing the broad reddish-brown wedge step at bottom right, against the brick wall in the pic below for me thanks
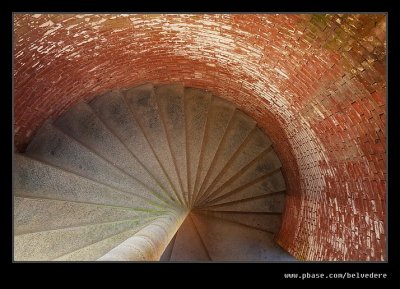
[192,213,294,262]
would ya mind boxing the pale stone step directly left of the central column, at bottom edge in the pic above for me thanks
[54,218,154,261]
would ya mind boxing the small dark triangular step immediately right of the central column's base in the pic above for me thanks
[170,215,211,261]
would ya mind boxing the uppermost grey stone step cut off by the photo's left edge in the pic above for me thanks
[14,154,166,211]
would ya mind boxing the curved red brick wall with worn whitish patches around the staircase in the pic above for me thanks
[14,14,386,260]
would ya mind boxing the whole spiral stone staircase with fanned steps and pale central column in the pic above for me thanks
[14,84,294,262]
